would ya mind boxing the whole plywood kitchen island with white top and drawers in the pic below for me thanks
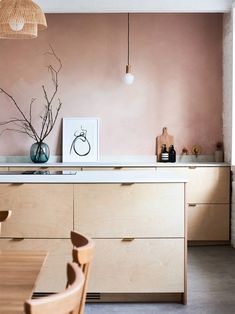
[0,170,187,303]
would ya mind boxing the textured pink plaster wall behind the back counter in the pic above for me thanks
[0,14,222,155]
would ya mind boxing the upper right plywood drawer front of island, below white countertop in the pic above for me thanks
[74,183,184,238]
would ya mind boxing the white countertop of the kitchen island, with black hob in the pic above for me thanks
[0,170,188,184]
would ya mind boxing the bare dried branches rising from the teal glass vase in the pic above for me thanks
[0,46,62,143]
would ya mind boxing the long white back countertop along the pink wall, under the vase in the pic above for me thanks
[0,161,230,168]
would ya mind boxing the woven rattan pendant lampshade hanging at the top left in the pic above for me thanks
[0,0,47,39]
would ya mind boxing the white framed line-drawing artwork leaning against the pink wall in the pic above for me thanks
[63,118,99,162]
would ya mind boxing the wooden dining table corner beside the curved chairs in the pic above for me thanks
[0,250,47,314]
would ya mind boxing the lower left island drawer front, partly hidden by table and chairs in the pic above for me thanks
[0,239,72,292]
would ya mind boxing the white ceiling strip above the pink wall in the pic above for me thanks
[34,0,233,13]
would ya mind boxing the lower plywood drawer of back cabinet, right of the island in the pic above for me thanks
[188,204,229,241]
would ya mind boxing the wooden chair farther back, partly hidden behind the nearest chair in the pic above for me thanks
[70,231,95,314]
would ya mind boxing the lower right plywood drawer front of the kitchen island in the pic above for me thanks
[88,239,184,293]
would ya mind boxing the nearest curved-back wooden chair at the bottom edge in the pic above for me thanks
[24,263,84,314]
